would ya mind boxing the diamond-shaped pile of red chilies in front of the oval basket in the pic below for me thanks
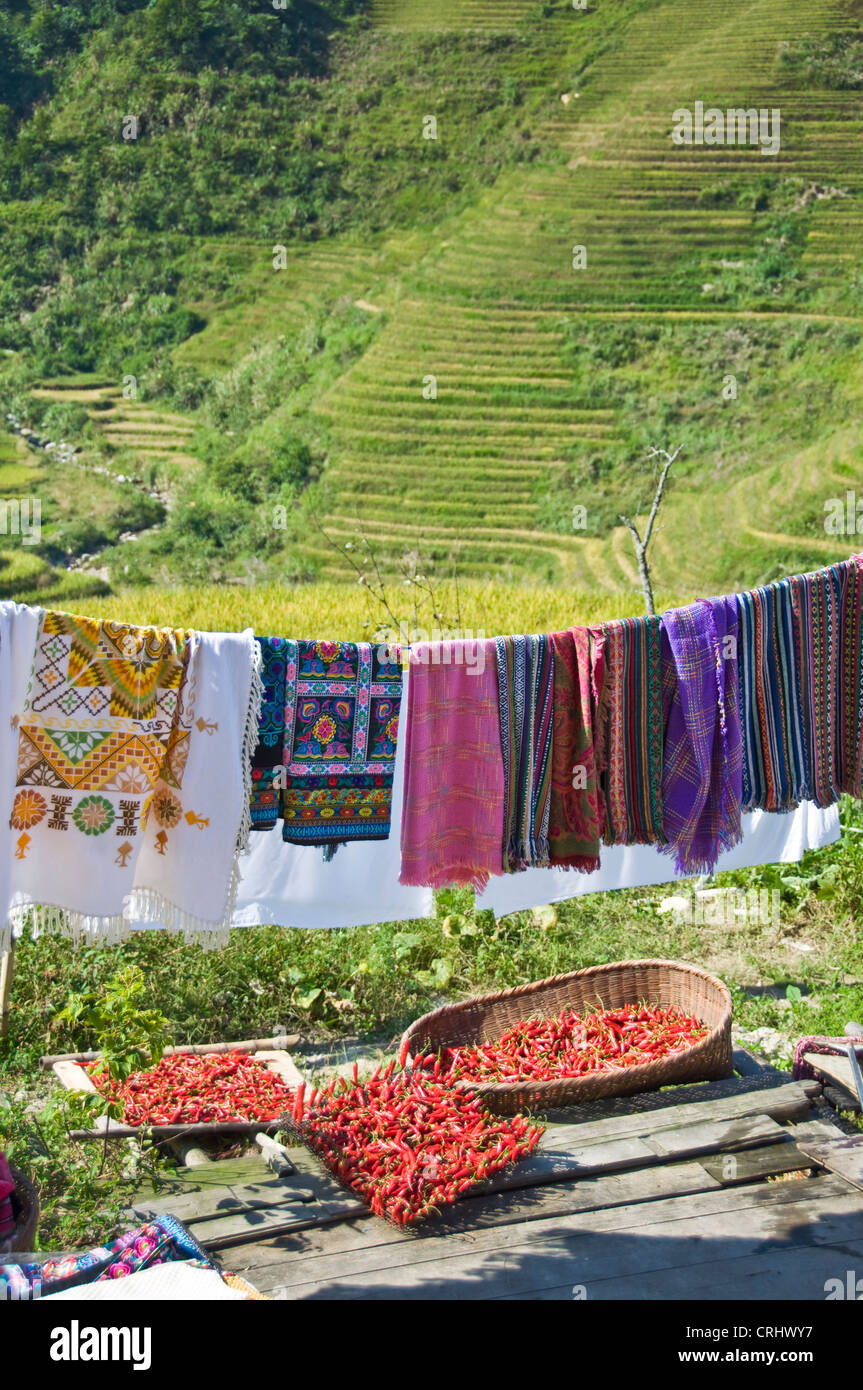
[292,1056,542,1226]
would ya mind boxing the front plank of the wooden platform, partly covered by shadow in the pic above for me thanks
[254,1177,863,1300]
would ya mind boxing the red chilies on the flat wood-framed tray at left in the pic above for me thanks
[86,1052,293,1125]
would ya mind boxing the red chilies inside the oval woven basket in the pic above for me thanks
[442,1004,707,1083]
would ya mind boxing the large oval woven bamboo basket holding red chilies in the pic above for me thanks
[402,960,734,1115]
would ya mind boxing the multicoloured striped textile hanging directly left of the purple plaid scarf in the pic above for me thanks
[599,617,664,845]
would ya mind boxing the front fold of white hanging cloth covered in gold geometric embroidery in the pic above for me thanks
[10,612,196,934]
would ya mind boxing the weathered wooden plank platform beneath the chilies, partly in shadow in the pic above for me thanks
[112,1056,863,1301]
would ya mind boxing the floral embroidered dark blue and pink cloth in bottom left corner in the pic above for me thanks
[0,1216,215,1301]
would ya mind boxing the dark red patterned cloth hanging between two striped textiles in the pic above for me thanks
[549,627,605,873]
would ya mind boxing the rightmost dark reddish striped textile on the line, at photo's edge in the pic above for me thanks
[788,556,863,806]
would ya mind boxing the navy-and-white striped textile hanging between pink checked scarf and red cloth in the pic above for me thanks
[495,637,554,873]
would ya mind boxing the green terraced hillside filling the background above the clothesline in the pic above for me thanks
[0,0,863,594]
